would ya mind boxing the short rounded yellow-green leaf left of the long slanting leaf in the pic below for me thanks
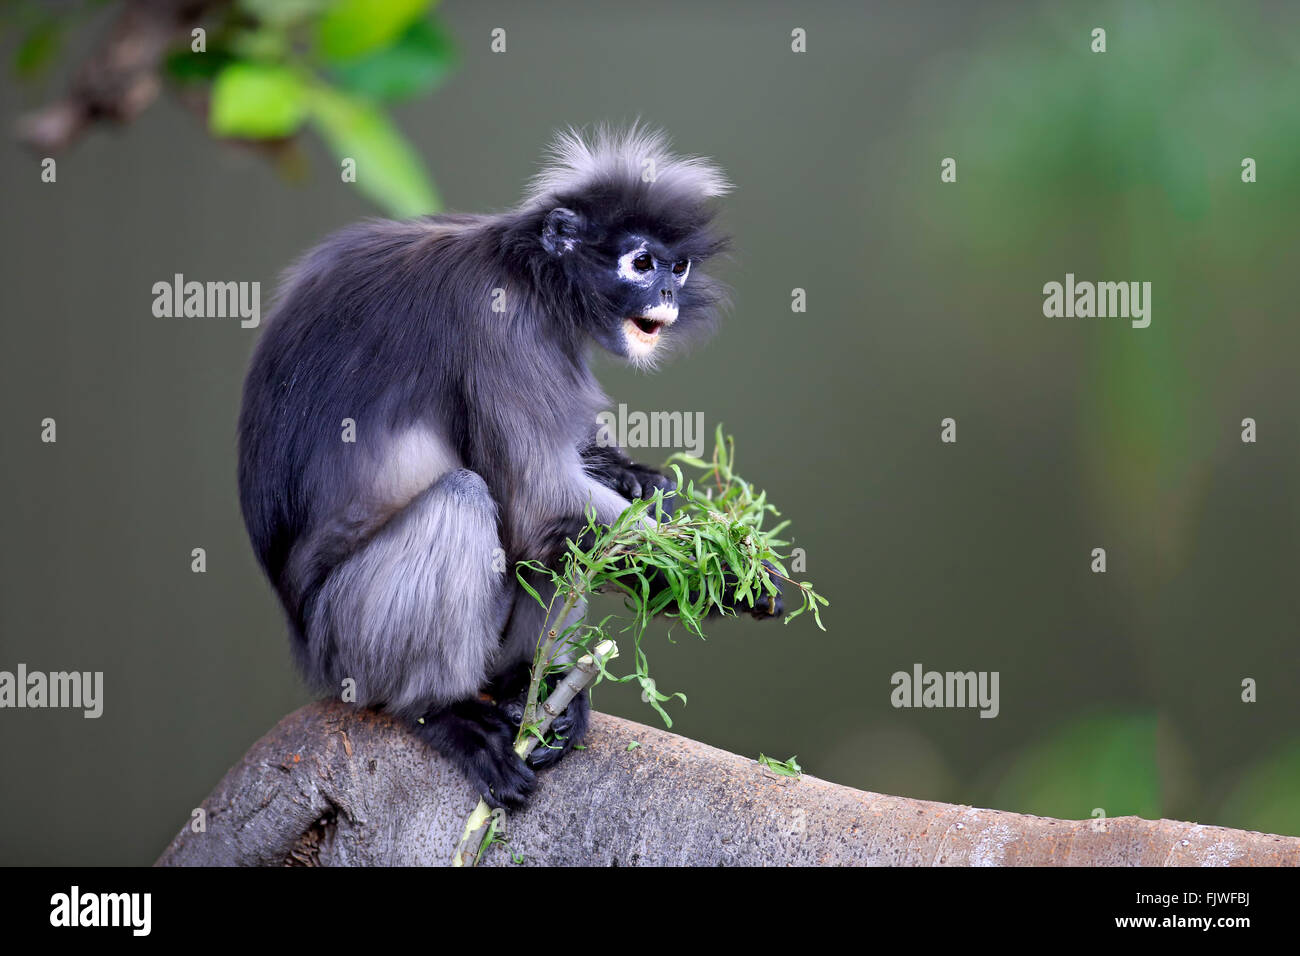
[208,62,307,139]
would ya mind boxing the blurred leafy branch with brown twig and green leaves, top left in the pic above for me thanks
[0,0,456,217]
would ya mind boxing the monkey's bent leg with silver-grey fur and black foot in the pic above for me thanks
[311,470,534,805]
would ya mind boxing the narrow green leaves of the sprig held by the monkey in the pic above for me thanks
[519,428,828,739]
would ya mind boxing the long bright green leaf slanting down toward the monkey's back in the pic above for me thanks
[311,86,441,219]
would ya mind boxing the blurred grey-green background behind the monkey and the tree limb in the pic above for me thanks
[0,0,1300,864]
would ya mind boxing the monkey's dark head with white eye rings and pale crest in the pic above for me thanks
[529,126,731,365]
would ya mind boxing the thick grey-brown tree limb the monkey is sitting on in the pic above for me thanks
[157,702,1300,866]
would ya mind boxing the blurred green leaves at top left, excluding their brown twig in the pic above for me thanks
[3,0,456,217]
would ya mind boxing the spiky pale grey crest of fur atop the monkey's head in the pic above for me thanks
[524,122,732,213]
